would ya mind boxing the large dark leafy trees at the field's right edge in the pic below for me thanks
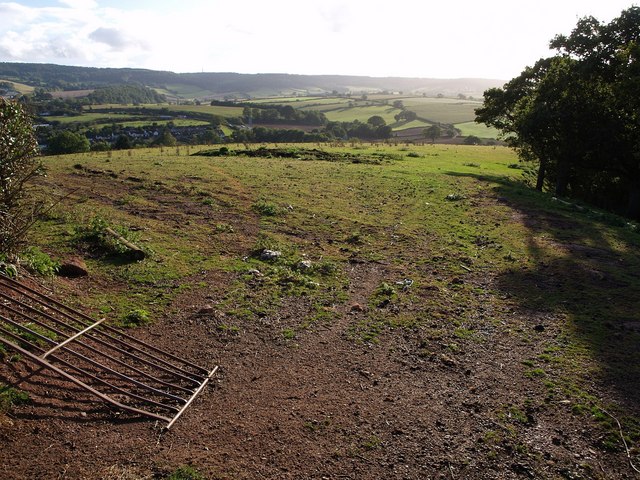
[476,6,640,219]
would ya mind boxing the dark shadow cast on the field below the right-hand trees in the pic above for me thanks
[449,172,640,413]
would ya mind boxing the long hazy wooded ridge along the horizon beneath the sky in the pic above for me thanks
[0,62,504,99]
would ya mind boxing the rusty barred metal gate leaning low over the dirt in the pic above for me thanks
[0,274,218,429]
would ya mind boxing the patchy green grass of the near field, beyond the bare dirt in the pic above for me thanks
[23,146,640,474]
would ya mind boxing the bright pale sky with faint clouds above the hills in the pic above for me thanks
[0,0,634,80]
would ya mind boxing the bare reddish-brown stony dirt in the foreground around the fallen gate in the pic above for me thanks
[0,264,633,479]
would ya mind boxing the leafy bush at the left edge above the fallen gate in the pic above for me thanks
[0,98,42,255]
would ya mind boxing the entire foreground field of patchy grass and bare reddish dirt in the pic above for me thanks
[0,144,640,479]
